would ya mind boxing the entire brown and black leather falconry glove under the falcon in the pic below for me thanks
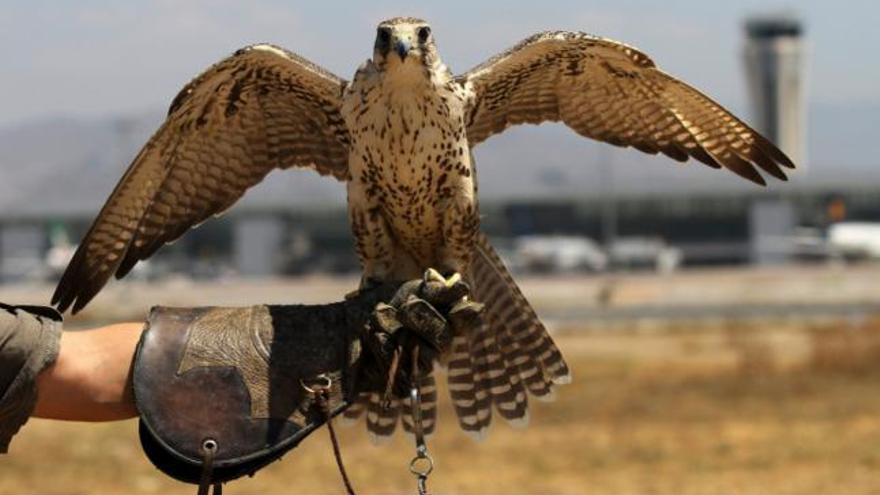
[133,281,466,483]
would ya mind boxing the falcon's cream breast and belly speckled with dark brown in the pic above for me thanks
[343,61,479,280]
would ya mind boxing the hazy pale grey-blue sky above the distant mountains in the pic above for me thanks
[0,0,880,126]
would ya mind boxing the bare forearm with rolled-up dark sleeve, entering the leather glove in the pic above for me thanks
[0,303,143,452]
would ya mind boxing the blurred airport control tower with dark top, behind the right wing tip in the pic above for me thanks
[745,14,806,169]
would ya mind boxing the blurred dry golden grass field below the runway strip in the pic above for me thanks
[0,319,880,495]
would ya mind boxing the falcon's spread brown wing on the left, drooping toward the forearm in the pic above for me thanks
[52,45,348,313]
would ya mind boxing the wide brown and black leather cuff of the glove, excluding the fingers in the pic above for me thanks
[134,305,359,483]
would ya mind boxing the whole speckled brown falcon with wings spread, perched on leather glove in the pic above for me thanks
[52,17,794,436]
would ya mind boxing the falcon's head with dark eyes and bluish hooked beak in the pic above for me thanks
[373,17,439,71]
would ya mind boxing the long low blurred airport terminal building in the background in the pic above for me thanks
[6,183,880,281]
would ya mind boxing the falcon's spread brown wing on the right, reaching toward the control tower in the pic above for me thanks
[457,32,794,184]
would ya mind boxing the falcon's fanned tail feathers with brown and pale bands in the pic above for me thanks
[343,233,571,441]
